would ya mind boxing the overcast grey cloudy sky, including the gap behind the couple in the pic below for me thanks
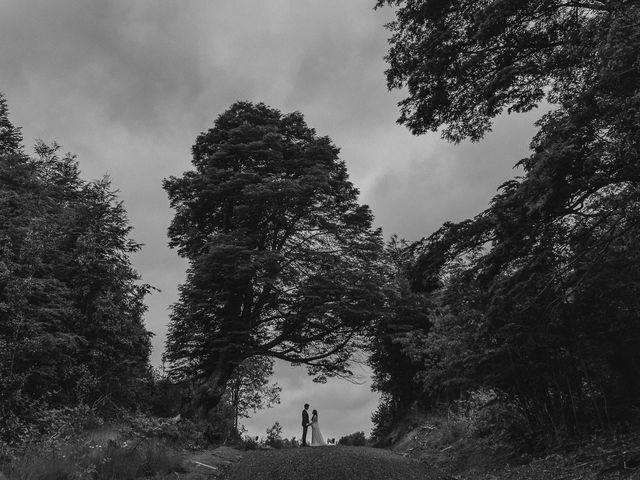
[0,0,539,437]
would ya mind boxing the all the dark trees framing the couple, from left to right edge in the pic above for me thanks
[0,0,640,446]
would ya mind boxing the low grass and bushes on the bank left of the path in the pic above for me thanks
[0,405,230,480]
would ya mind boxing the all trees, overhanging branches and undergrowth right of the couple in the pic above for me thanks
[370,0,640,478]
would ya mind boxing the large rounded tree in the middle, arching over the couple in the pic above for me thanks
[164,102,384,412]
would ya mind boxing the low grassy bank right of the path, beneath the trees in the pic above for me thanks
[393,415,640,480]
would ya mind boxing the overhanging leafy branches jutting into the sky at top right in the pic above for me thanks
[377,0,624,142]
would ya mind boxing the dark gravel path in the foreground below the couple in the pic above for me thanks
[224,446,438,480]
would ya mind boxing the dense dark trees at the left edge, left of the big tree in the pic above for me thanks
[0,92,150,440]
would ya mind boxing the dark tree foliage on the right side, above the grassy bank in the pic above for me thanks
[370,1,640,435]
